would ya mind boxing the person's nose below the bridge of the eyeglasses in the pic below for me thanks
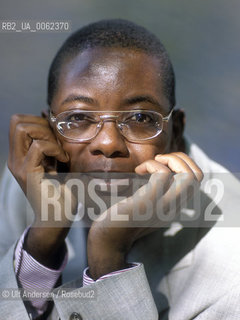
[90,121,129,158]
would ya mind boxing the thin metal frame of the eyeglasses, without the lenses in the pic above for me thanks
[49,107,174,142]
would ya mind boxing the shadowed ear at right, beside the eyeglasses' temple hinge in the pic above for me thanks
[171,109,185,152]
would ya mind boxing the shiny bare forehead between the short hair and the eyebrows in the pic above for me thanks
[52,48,169,111]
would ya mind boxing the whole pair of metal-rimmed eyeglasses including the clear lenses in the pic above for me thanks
[50,109,173,142]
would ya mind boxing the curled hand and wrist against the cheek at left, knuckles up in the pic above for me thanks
[8,115,69,267]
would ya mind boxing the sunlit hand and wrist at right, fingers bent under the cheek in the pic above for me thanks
[88,152,203,279]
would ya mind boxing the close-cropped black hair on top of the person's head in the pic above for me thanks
[47,19,175,107]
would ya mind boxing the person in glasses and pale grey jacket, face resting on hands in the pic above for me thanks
[0,20,239,320]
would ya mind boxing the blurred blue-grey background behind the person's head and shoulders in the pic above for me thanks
[0,0,240,173]
